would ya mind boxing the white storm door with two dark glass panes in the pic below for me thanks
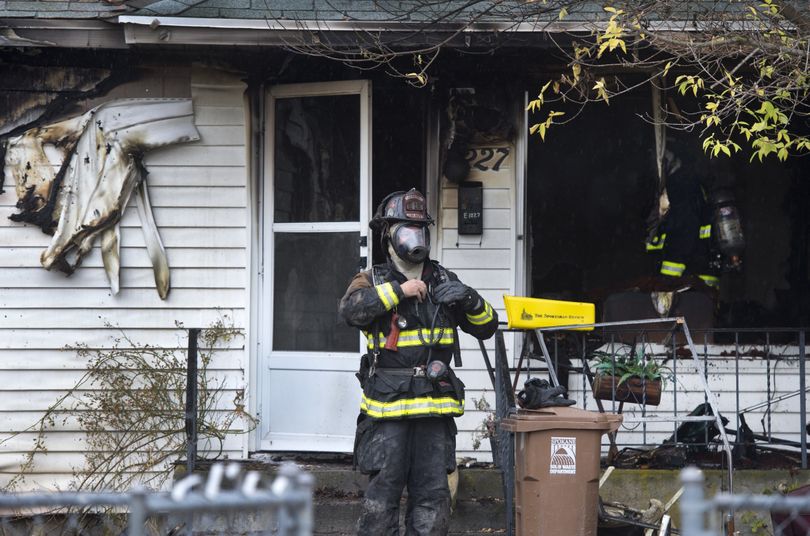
[258,81,371,452]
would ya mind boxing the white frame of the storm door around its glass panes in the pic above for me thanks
[251,80,371,451]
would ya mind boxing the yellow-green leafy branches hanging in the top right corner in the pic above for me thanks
[516,0,810,161]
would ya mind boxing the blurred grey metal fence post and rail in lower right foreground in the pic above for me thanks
[680,467,810,536]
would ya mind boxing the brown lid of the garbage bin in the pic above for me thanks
[500,406,622,432]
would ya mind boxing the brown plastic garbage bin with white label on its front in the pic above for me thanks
[500,407,622,536]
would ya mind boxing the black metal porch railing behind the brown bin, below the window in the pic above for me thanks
[480,318,810,536]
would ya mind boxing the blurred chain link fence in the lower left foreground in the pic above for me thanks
[0,463,313,536]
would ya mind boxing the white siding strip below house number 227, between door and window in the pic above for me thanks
[435,143,516,461]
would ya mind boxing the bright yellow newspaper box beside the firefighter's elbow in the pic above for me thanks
[503,296,596,330]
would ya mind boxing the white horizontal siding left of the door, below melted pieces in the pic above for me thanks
[0,69,248,488]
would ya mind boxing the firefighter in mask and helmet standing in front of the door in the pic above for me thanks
[339,189,498,536]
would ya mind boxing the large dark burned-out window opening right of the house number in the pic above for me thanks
[527,84,810,328]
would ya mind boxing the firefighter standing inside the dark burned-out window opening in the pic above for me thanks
[646,151,720,289]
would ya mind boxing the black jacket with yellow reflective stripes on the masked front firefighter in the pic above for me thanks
[339,261,498,419]
